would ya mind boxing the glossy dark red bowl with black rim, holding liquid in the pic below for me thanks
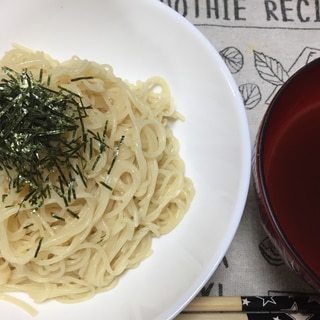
[252,59,320,292]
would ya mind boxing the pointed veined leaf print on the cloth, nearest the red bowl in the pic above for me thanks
[253,51,289,86]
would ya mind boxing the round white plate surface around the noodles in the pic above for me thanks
[0,0,251,320]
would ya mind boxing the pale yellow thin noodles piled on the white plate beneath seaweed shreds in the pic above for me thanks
[0,47,194,302]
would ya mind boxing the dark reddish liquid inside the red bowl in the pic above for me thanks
[264,104,320,277]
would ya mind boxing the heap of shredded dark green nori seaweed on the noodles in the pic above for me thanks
[0,67,123,214]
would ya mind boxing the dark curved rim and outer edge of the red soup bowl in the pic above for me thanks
[255,58,320,289]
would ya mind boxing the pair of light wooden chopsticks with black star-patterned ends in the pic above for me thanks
[176,295,320,320]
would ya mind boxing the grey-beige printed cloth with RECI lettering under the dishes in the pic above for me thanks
[161,0,320,296]
